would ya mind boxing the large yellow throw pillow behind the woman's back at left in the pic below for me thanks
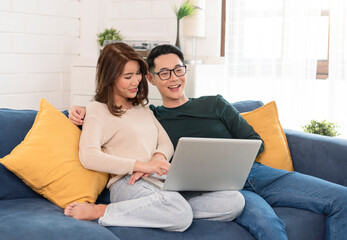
[0,99,108,208]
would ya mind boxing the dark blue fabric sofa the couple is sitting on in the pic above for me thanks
[0,101,347,240]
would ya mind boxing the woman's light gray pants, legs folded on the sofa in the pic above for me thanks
[99,175,245,232]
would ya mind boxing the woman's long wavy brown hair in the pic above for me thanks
[94,42,148,116]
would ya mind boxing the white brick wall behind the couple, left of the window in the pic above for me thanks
[0,0,221,109]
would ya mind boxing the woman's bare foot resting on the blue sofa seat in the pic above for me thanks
[64,202,107,220]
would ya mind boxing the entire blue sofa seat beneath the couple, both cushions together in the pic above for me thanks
[0,198,326,240]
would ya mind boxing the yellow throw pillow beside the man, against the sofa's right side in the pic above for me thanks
[241,101,294,171]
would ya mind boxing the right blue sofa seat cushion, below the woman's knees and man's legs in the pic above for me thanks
[108,207,326,240]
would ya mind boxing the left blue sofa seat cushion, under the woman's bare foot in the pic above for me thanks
[0,198,119,240]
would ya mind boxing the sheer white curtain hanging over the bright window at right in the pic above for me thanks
[223,0,347,137]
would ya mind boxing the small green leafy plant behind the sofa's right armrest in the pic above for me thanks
[302,120,340,137]
